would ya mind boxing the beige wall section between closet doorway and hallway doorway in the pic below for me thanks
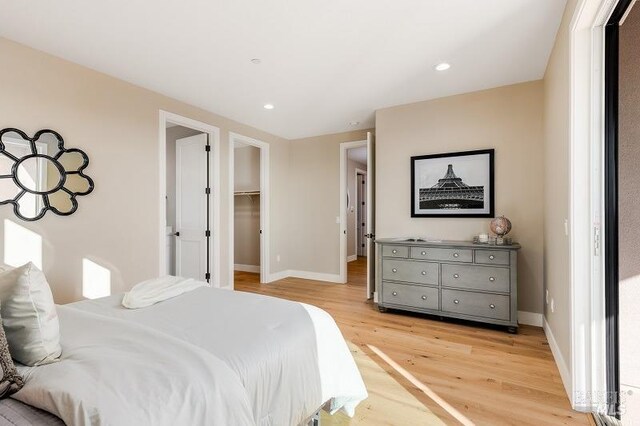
[286,130,367,275]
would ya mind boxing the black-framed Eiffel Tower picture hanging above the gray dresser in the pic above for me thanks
[411,149,495,218]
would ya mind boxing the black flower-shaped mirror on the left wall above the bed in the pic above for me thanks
[0,129,93,221]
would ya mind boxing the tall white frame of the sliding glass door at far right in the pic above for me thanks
[568,0,628,412]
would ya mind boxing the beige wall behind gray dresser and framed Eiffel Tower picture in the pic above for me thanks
[376,81,543,313]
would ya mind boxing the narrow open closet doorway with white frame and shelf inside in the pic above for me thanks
[229,133,269,288]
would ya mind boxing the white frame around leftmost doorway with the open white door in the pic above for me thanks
[157,110,221,287]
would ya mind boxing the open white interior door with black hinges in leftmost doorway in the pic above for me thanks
[176,133,209,281]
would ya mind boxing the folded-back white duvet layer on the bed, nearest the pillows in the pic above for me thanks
[13,306,255,426]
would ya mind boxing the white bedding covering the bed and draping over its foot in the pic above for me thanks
[13,287,367,426]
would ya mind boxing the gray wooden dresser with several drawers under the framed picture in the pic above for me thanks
[376,239,520,333]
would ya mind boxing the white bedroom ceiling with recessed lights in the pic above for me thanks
[0,0,565,139]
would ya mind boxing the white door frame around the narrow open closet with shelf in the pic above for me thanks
[229,132,273,289]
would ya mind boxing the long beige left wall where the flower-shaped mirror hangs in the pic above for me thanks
[0,38,289,303]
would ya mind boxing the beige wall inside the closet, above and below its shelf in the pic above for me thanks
[233,146,260,266]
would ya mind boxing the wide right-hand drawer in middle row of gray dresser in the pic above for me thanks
[442,264,510,293]
